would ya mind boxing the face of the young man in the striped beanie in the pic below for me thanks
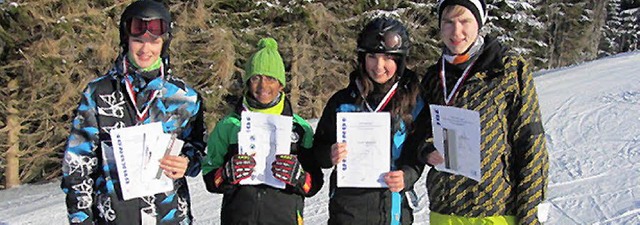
[440,5,479,55]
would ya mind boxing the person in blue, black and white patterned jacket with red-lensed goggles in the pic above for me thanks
[61,0,207,224]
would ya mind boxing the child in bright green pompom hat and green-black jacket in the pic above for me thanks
[202,38,324,224]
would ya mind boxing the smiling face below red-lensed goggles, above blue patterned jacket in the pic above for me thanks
[129,37,164,69]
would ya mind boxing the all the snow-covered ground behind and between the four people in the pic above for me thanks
[0,52,640,225]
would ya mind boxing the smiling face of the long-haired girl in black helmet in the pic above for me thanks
[365,53,398,84]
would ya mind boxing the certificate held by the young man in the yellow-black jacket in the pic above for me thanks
[429,105,482,182]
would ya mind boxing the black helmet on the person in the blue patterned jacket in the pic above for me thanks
[120,0,173,58]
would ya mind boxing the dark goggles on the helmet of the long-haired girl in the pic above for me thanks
[358,30,405,54]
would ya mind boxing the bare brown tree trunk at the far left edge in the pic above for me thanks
[4,101,22,188]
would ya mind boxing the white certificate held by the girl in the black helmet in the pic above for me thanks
[336,112,391,188]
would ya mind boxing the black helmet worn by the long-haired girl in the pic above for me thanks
[357,17,411,77]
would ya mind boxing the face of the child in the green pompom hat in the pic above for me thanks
[248,75,284,104]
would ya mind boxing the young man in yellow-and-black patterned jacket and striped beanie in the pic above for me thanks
[407,0,548,225]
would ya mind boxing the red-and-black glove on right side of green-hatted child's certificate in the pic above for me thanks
[271,155,306,186]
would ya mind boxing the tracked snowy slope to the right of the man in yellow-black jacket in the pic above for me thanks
[536,53,640,225]
